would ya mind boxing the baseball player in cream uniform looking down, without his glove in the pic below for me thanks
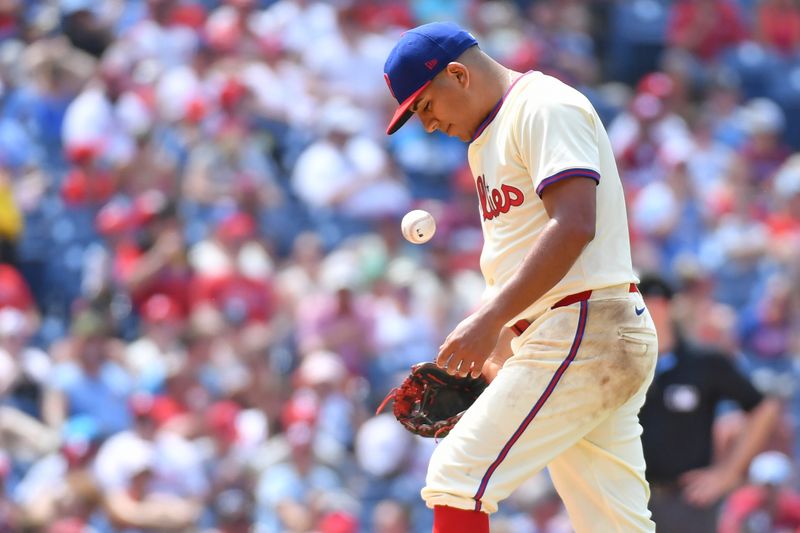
[384,23,657,533]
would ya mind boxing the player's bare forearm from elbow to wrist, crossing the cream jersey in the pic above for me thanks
[478,218,594,324]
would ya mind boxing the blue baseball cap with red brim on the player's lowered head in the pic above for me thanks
[383,22,478,135]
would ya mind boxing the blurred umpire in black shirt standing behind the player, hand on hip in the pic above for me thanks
[639,275,781,533]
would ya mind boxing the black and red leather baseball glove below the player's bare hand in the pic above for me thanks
[375,363,487,438]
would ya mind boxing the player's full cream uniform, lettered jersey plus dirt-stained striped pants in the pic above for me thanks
[421,72,658,533]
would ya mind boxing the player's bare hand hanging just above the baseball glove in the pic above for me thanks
[436,311,502,377]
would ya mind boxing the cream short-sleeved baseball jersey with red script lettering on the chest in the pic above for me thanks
[469,72,638,323]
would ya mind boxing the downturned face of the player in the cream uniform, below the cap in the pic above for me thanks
[411,64,480,142]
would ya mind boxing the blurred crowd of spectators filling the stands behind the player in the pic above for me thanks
[0,0,800,533]
